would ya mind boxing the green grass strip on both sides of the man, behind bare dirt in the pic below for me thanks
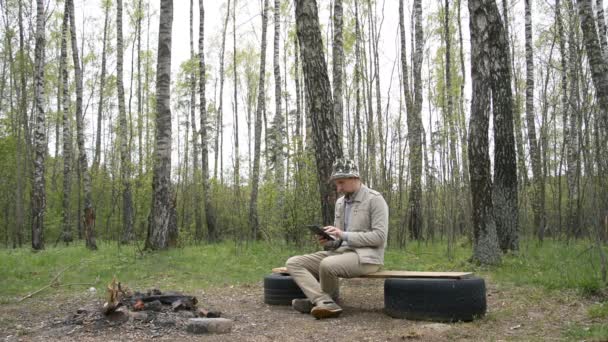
[0,236,608,304]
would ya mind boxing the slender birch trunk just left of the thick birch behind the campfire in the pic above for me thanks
[116,0,133,243]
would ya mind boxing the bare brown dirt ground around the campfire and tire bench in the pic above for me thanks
[0,279,593,342]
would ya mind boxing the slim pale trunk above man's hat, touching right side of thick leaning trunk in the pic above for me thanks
[332,0,344,140]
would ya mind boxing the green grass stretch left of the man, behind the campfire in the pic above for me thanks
[0,242,303,301]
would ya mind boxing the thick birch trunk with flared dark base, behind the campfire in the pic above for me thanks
[146,0,178,250]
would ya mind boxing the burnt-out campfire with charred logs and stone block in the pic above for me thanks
[64,279,232,334]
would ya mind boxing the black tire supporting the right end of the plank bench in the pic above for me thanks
[384,278,486,322]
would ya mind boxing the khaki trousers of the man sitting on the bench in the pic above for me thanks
[285,247,380,304]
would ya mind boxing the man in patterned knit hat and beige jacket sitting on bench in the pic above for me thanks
[286,159,388,319]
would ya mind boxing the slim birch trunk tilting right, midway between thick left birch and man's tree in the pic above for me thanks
[249,0,268,239]
